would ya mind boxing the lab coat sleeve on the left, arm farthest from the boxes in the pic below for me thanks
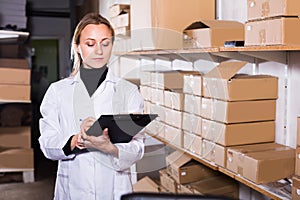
[39,84,75,160]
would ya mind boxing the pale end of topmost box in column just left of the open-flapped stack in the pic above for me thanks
[183,74,202,96]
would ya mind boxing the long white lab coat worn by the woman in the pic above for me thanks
[39,69,144,200]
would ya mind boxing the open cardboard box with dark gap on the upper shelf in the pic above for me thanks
[184,19,244,48]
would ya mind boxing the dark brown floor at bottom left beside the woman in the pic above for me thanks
[0,151,57,200]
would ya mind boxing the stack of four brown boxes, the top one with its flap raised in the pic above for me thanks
[201,62,278,167]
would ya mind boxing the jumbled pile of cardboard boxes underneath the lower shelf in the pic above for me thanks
[159,151,238,199]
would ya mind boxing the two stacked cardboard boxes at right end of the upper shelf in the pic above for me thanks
[245,0,300,46]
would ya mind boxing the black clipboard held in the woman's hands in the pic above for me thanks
[86,114,158,143]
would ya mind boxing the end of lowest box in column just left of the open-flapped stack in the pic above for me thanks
[183,131,202,156]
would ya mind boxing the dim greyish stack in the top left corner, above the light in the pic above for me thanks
[0,0,27,30]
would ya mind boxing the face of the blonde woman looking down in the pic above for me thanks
[77,24,112,68]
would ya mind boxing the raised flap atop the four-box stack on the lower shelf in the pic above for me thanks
[204,62,247,80]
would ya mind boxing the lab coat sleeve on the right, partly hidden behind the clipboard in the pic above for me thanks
[112,85,145,171]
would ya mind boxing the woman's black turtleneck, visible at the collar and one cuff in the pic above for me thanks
[63,66,108,156]
